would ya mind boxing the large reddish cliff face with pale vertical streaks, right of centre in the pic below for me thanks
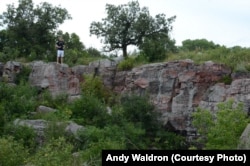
[123,60,231,135]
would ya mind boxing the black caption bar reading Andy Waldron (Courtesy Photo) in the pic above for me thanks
[102,150,250,166]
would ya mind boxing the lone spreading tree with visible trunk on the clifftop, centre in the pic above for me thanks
[90,1,175,57]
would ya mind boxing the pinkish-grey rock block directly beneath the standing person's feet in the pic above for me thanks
[29,62,82,95]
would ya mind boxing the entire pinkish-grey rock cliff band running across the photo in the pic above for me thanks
[3,60,250,140]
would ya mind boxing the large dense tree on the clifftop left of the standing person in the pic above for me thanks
[0,0,71,59]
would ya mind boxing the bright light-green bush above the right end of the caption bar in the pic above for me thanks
[192,100,249,150]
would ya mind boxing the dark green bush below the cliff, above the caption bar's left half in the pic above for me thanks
[121,95,186,149]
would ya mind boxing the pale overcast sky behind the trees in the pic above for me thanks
[0,0,250,49]
